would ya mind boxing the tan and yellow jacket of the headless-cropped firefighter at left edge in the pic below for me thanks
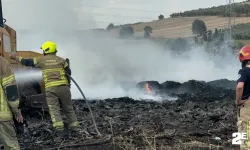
[0,56,21,121]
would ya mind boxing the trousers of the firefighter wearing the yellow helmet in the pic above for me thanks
[46,85,79,130]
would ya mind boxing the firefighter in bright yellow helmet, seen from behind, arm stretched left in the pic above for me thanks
[11,41,81,137]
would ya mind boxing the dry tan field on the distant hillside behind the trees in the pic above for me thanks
[111,16,250,38]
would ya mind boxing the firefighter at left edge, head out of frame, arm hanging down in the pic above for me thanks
[0,56,23,150]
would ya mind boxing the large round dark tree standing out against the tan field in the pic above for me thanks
[192,19,207,35]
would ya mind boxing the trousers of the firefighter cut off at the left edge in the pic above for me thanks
[0,121,20,150]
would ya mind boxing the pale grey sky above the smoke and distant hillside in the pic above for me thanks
[2,0,246,30]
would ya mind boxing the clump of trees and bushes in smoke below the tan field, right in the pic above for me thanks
[164,19,230,55]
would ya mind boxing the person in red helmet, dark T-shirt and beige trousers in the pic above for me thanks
[236,45,250,150]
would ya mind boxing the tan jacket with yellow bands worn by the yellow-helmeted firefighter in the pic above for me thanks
[16,54,71,88]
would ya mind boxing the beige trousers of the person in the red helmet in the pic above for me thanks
[237,99,250,150]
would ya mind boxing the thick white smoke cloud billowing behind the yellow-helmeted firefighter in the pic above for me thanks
[0,0,240,101]
